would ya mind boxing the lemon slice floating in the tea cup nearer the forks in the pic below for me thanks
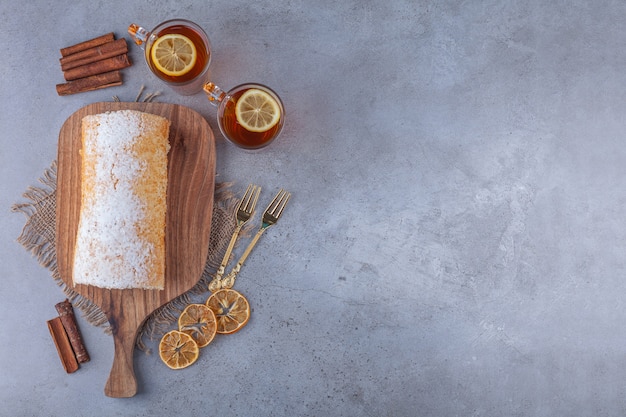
[235,88,280,132]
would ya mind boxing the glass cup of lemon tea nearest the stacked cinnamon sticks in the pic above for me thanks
[128,19,211,95]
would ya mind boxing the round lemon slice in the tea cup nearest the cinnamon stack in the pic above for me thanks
[150,33,198,77]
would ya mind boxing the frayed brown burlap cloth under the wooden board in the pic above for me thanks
[12,161,238,351]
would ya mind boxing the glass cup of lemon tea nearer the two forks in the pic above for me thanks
[203,82,285,150]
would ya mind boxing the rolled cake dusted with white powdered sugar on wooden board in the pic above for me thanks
[73,110,169,289]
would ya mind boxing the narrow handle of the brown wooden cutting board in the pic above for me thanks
[104,314,138,398]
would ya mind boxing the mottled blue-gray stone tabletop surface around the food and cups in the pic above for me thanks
[0,0,626,416]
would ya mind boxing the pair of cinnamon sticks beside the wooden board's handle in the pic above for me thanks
[48,299,89,374]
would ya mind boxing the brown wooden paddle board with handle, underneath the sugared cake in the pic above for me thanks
[56,102,215,397]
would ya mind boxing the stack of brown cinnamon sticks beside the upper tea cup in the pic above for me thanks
[56,33,131,96]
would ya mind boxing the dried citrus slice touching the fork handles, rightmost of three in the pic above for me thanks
[206,289,250,334]
